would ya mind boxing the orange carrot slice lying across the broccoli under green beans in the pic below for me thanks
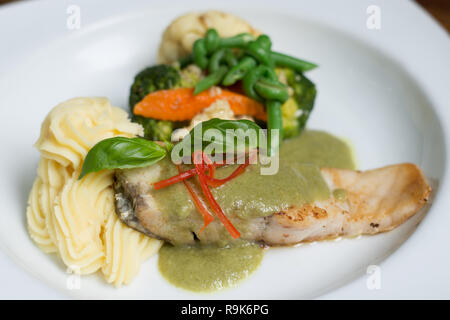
[134,88,267,121]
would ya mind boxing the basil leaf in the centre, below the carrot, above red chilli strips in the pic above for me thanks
[177,118,261,156]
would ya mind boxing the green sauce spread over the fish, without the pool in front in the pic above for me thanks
[153,131,355,219]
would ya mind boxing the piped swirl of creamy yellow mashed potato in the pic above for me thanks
[27,98,161,286]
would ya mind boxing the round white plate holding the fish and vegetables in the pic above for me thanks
[0,0,450,299]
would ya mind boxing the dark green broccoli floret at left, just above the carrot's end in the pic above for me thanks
[130,64,181,113]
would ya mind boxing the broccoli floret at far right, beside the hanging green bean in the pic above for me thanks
[276,68,317,138]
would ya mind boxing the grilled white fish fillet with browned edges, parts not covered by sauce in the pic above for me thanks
[115,163,431,245]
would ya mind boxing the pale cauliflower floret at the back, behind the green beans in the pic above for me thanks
[158,11,260,64]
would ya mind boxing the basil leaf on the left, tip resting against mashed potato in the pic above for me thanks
[79,137,167,179]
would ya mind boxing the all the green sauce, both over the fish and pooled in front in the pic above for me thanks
[154,131,355,291]
